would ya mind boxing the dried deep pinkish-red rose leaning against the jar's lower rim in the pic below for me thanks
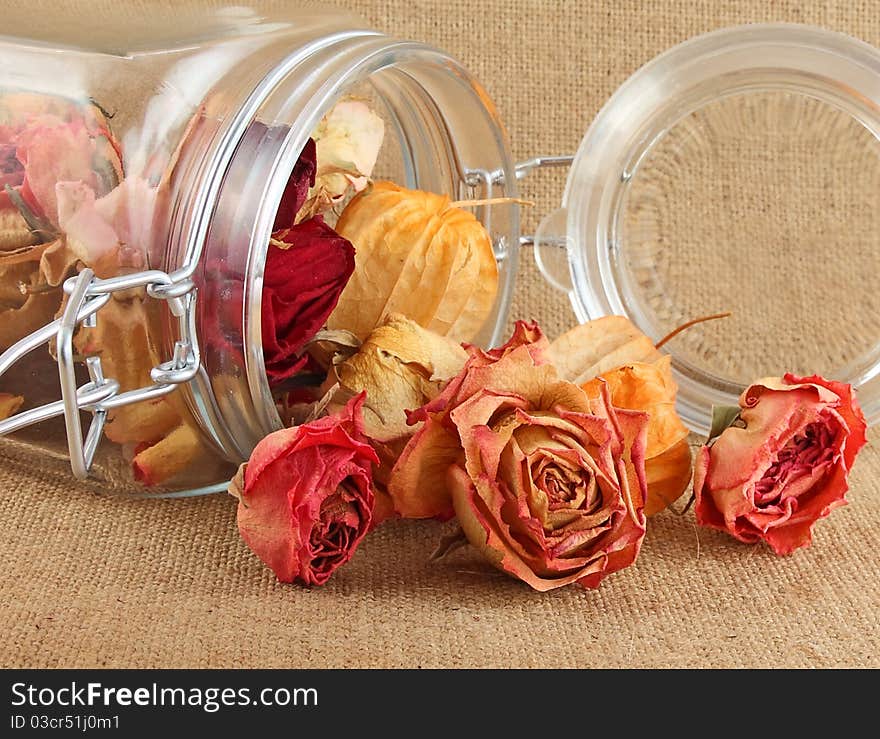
[229,395,377,585]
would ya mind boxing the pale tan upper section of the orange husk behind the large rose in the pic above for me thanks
[549,316,664,385]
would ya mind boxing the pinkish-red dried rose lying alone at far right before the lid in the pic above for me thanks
[694,374,866,554]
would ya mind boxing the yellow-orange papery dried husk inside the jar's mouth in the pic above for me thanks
[329,182,498,341]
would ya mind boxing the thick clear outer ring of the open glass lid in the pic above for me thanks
[563,24,880,433]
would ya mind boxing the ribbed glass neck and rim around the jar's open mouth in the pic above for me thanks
[178,36,519,461]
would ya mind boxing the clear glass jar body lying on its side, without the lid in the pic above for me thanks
[0,7,519,494]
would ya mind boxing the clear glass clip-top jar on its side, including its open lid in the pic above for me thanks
[0,7,880,495]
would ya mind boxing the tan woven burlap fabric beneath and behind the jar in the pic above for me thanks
[0,0,880,667]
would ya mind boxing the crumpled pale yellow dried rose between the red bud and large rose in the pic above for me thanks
[328,314,468,523]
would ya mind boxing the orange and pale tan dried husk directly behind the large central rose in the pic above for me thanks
[549,316,691,516]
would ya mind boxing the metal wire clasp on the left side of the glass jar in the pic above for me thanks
[0,269,200,480]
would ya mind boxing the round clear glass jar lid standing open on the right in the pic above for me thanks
[537,24,880,432]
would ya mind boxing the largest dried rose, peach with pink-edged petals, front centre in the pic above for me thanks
[391,322,648,591]
